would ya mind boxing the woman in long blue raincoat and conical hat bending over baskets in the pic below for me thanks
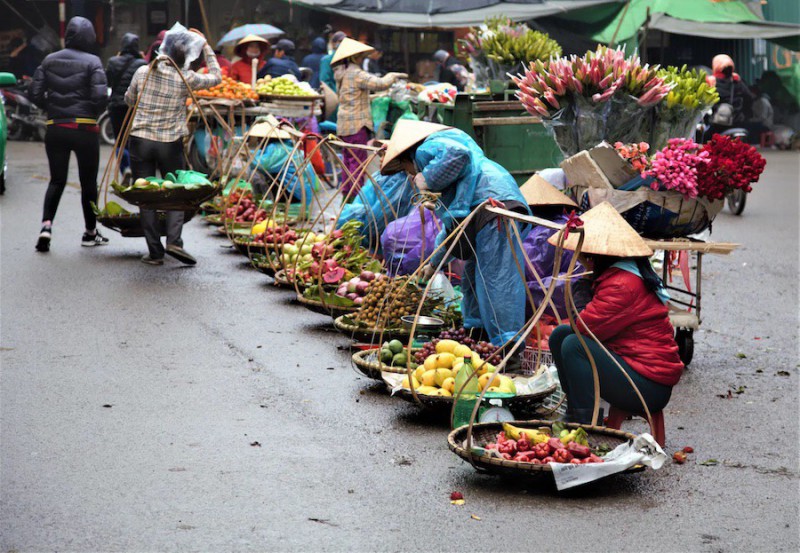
[381,120,530,346]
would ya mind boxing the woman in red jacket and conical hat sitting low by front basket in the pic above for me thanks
[549,202,683,424]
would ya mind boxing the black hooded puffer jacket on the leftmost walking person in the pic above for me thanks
[31,17,108,119]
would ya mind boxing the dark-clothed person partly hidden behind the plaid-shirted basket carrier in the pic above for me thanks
[106,33,145,185]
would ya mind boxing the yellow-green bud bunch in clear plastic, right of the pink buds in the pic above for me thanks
[650,65,719,150]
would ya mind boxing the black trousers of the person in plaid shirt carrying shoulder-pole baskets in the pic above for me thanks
[128,136,184,259]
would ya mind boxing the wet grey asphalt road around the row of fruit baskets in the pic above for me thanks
[0,143,800,552]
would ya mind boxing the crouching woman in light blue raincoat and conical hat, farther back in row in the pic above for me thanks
[249,120,319,206]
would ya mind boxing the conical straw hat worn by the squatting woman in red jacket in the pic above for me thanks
[547,202,653,257]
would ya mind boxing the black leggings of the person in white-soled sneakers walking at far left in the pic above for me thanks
[42,125,100,230]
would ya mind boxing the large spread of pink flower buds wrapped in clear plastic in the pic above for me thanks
[513,46,672,156]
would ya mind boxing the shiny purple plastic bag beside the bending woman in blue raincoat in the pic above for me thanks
[381,209,442,276]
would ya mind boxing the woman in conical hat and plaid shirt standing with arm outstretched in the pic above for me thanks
[331,38,408,194]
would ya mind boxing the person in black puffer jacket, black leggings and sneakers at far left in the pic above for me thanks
[31,17,108,252]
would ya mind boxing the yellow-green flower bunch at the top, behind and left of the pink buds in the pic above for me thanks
[461,17,561,86]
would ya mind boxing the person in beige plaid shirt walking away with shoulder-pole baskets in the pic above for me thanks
[125,29,222,265]
